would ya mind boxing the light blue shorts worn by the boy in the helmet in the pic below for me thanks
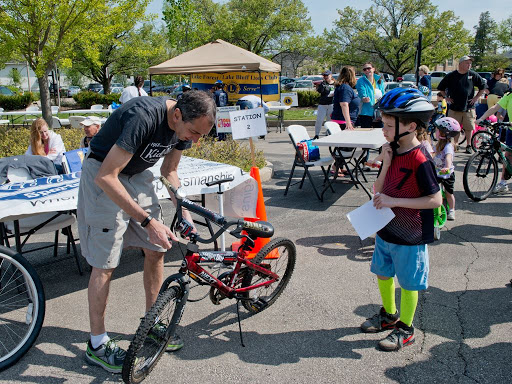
[370,236,429,291]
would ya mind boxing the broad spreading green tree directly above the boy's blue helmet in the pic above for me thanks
[325,0,470,76]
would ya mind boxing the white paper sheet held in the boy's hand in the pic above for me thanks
[347,200,395,240]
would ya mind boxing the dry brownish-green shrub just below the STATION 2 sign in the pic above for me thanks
[183,135,265,172]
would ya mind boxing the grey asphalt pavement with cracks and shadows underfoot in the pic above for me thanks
[0,127,512,384]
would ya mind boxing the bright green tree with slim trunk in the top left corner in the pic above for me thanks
[0,0,105,123]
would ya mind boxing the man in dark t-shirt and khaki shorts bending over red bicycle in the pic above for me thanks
[77,91,216,373]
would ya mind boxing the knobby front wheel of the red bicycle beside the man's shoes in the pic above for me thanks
[123,286,186,383]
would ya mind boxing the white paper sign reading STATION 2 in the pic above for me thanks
[229,108,267,140]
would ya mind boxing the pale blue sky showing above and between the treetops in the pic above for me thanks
[146,0,512,34]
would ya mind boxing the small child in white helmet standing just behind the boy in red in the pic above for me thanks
[434,117,461,220]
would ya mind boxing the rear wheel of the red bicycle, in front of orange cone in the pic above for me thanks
[242,238,296,313]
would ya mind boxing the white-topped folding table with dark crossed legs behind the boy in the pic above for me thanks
[313,128,387,199]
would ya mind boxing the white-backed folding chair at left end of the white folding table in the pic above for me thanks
[284,125,334,201]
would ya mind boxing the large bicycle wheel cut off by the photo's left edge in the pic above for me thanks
[0,247,45,371]
